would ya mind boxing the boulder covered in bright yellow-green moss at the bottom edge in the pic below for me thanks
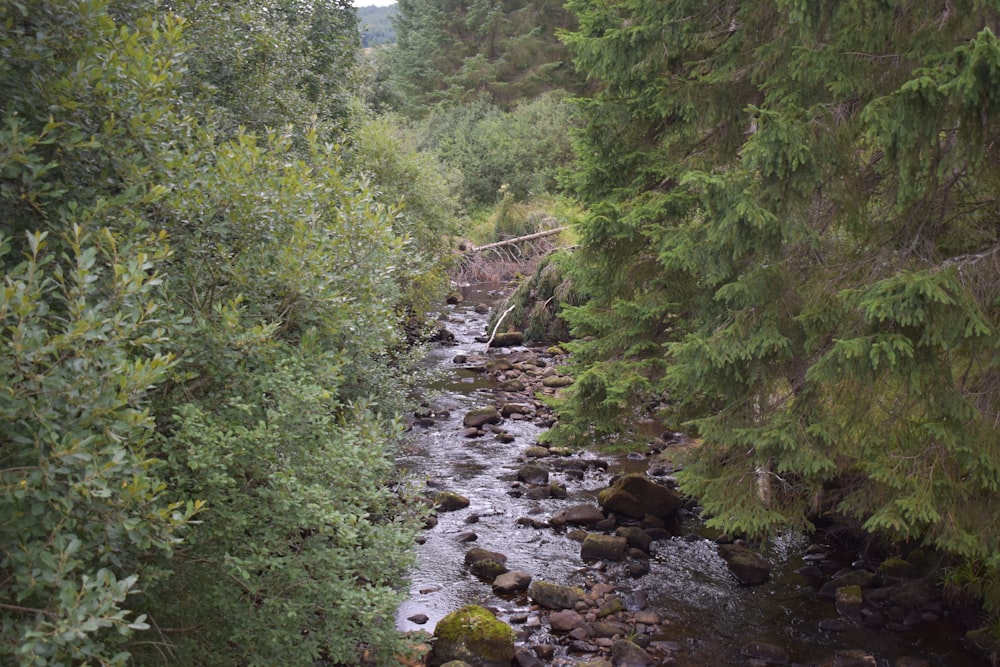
[428,605,514,667]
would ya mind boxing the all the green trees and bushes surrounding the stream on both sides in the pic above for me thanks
[0,0,1000,665]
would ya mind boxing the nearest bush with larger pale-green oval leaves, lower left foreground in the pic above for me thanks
[0,225,199,665]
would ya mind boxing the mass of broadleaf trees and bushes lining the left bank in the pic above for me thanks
[0,0,447,666]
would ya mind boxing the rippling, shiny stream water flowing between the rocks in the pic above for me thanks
[396,285,988,667]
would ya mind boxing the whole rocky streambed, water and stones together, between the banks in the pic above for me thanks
[397,286,987,667]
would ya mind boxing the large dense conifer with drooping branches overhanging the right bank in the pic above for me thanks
[553,0,1000,640]
